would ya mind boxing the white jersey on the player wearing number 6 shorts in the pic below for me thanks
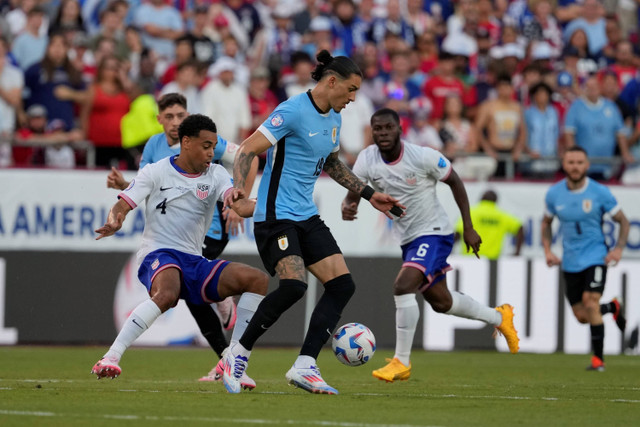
[353,142,453,245]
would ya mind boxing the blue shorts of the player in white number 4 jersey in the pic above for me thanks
[138,249,230,304]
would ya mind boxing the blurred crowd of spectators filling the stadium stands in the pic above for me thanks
[0,0,640,183]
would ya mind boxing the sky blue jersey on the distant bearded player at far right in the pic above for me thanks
[545,178,620,273]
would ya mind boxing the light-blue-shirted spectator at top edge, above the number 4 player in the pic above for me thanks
[134,0,184,60]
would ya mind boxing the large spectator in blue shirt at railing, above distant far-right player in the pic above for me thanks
[564,76,634,179]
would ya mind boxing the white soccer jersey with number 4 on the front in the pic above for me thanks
[118,156,232,263]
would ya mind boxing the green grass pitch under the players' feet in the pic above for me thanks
[0,346,640,427]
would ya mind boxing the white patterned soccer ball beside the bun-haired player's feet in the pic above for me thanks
[331,323,376,366]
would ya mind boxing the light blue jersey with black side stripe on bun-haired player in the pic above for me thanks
[253,92,342,222]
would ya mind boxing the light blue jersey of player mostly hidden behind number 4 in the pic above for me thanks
[140,132,227,240]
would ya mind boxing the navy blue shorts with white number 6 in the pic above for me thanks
[401,234,453,292]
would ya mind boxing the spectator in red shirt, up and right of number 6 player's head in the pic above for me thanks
[423,52,474,121]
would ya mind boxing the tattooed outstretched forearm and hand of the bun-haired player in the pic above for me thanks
[323,153,406,219]
